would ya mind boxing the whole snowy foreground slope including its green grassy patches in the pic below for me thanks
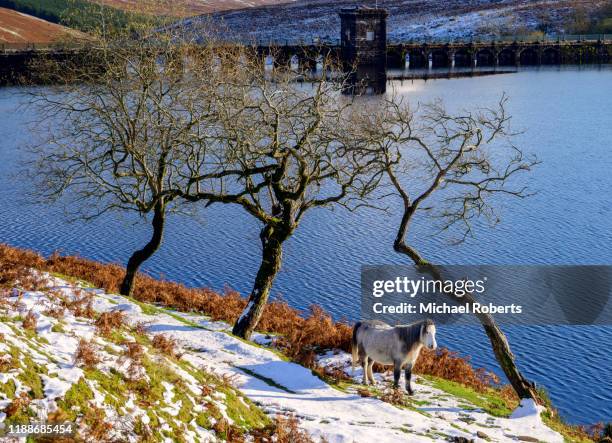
[0,274,563,442]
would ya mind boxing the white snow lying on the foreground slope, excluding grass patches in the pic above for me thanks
[0,277,563,442]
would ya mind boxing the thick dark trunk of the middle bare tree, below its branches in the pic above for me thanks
[232,226,288,340]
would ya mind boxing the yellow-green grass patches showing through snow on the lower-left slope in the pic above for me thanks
[0,274,270,442]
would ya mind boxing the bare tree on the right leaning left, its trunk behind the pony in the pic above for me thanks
[361,96,538,399]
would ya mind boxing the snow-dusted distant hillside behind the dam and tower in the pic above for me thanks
[188,0,602,43]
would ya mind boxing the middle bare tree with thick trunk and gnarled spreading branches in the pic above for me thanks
[181,57,382,338]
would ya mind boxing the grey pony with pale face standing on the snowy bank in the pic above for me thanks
[352,319,437,395]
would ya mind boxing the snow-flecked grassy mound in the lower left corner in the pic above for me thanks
[0,306,271,442]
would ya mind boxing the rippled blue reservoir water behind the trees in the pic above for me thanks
[0,68,612,423]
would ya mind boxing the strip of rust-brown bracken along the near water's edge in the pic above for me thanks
[0,243,608,432]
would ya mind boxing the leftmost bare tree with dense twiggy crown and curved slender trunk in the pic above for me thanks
[27,24,242,295]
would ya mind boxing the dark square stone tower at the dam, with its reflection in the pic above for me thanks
[340,7,389,94]
